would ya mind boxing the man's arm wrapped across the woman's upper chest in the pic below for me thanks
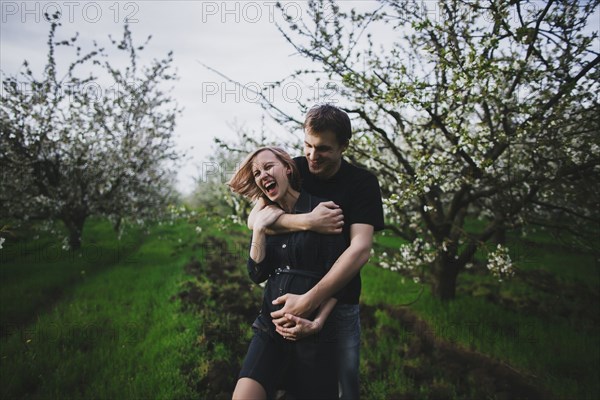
[248,198,344,235]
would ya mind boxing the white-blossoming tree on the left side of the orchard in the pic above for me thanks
[0,15,179,248]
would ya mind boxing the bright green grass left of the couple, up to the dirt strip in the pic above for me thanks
[0,222,205,399]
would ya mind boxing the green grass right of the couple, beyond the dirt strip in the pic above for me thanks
[362,227,600,399]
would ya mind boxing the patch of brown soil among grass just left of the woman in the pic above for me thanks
[174,237,262,399]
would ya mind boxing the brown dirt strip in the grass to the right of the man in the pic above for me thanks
[361,304,552,400]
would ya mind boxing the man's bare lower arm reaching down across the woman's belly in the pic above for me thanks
[271,224,374,325]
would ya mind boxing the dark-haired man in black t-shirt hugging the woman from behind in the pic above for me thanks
[248,104,383,399]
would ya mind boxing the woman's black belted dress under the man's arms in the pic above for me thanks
[239,191,346,399]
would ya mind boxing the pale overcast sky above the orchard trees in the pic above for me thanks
[0,0,360,192]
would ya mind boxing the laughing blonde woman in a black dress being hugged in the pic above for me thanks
[229,147,345,399]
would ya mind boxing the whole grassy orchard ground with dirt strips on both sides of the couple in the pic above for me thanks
[0,214,600,399]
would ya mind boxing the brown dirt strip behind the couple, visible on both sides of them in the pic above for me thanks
[177,238,552,400]
